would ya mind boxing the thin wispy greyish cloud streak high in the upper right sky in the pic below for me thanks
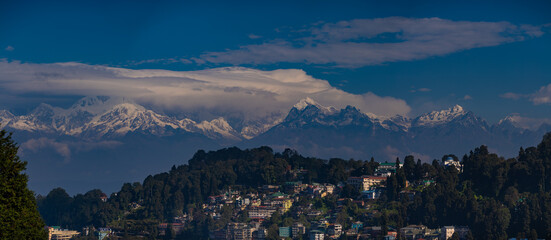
[192,17,544,68]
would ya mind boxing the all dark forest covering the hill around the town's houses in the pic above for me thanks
[37,133,551,239]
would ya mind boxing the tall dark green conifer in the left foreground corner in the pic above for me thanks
[0,130,47,239]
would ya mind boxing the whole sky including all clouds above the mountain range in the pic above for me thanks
[0,0,551,126]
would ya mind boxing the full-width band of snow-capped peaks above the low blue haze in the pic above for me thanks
[0,97,551,158]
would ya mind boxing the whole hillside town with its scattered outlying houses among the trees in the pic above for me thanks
[49,157,472,240]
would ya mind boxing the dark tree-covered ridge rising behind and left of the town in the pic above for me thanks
[38,147,378,229]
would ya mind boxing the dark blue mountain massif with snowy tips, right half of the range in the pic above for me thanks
[247,99,544,163]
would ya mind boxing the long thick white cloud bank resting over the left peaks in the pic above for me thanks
[0,61,410,120]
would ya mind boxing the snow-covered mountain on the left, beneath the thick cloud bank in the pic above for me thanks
[0,97,241,141]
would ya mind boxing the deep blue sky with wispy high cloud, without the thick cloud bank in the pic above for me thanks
[0,1,551,122]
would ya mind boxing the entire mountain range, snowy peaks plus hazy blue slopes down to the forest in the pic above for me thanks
[0,96,551,193]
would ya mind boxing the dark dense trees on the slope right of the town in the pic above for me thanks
[382,133,551,239]
